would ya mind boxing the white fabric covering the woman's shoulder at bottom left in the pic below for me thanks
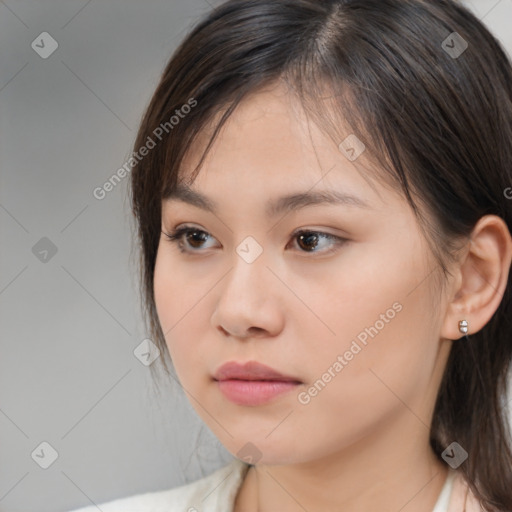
[67,459,249,512]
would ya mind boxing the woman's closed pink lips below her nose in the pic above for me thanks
[214,361,301,406]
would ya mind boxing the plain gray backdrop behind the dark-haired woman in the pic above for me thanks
[0,0,512,512]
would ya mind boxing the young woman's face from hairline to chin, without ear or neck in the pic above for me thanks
[154,83,450,464]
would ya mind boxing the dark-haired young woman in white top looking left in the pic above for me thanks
[71,0,512,512]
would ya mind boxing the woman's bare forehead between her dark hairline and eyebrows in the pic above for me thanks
[168,86,396,211]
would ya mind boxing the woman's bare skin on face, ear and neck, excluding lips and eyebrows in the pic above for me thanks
[154,85,512,512]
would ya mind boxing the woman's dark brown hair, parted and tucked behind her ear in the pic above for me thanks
[131,0,512,510]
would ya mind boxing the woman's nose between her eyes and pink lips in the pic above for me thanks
[211,247,284,339]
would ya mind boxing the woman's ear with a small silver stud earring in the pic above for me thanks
[440,215,512,340]
